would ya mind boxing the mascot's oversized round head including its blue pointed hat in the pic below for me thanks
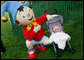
[1,1,34,26]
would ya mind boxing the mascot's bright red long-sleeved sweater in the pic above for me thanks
[23,13,49,41]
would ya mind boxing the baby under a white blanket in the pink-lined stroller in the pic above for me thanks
[49,26,71,50]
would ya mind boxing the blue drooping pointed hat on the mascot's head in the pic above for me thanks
[1,1,29,23]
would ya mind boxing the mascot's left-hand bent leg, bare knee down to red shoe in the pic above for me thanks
[26,40,37,59]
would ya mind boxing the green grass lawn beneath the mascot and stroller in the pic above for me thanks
[1,17,83,59]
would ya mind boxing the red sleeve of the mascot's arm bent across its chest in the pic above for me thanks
[23,27,35,41]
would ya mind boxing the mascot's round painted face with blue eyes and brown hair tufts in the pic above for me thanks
[16,6,35,26]
